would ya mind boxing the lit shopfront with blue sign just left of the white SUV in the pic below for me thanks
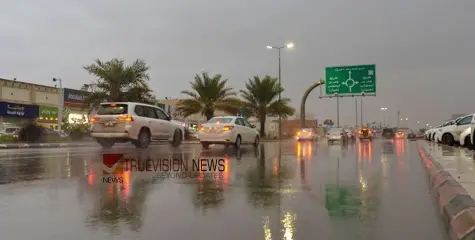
[64,88,89,123]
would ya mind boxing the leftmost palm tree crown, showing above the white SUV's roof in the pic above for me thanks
[82,58,155,107]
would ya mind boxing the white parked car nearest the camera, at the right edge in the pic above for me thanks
[435,114,475,146]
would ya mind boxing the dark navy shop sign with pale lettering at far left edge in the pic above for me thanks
[0,102,39,126]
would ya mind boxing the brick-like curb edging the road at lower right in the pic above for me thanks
[417,143,475,240]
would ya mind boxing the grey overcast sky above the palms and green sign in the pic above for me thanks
[0,0,475,127]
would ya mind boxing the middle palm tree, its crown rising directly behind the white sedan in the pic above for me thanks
[176,72,241,120]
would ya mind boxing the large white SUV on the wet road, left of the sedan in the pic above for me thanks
[91,102,183,148]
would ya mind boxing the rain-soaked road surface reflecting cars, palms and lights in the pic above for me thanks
[0,140,446,240]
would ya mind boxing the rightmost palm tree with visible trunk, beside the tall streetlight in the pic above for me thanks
[241,75,295,136]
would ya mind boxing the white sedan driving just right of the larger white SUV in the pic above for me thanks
[197,116,260,149]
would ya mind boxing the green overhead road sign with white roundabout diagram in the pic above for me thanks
[325,64,376,95]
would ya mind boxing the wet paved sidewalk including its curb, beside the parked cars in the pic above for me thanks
[417,140,475,240]
